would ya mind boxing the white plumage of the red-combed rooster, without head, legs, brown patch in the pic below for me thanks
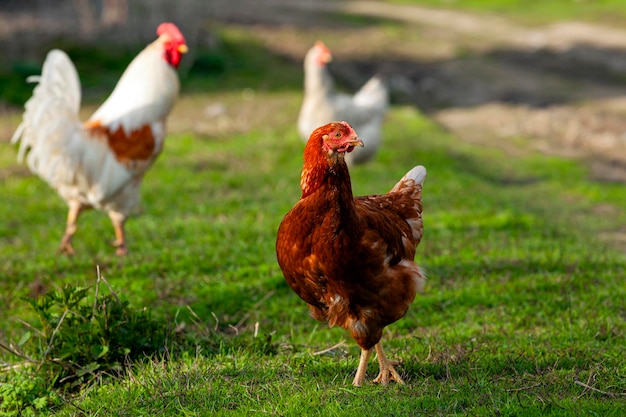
[12,40,179,215]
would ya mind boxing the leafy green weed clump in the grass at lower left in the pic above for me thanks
[0,276,166,415]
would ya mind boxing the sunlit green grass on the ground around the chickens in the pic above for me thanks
[0,7,626,416]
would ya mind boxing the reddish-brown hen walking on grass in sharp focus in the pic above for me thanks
[276,122,426,386]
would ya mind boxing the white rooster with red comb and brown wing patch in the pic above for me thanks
[11,23,187,255]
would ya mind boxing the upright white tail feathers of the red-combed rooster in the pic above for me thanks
[11,49,81,182]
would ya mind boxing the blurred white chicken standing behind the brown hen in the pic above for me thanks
[298,41,389,165]
